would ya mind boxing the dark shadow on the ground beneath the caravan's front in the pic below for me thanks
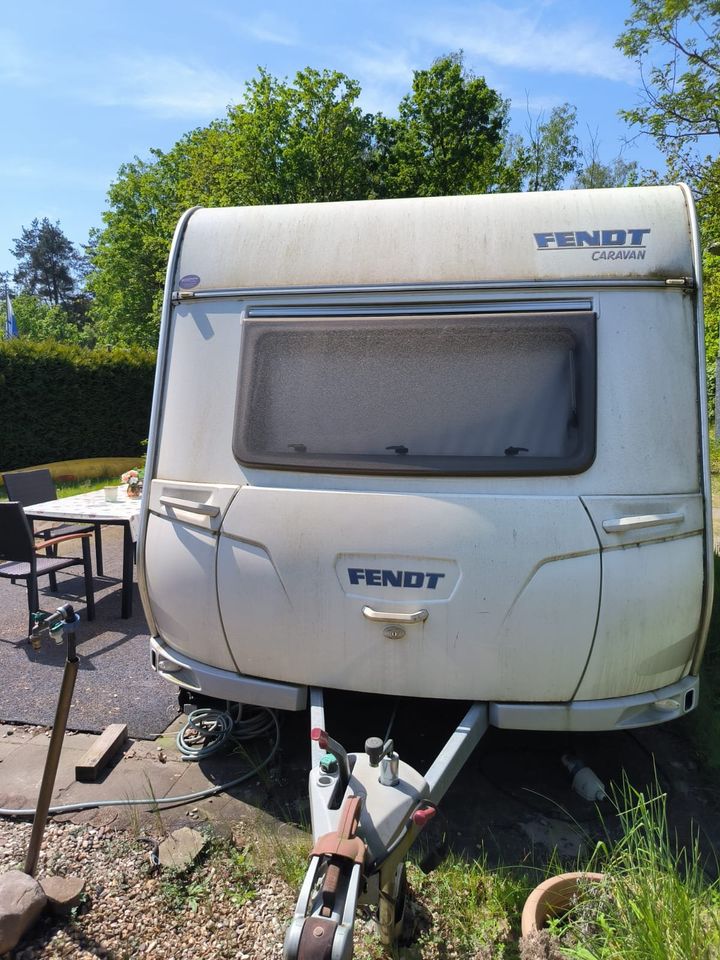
[187,693,720,876]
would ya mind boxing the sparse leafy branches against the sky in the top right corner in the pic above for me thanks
[616,0,720,189]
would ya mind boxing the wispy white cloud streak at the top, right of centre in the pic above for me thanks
[415,3,635,82]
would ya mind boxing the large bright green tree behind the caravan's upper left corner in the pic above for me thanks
[88,69,371,346]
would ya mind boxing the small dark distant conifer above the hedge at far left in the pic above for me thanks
[10,217,85,306]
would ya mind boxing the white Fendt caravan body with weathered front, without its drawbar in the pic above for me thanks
[138,186,712,730]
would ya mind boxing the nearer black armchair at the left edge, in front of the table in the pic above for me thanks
[0,500,95,636]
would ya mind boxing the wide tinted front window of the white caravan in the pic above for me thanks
[234,313,595,474]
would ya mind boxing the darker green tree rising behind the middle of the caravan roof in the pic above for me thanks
[373,53,508,197]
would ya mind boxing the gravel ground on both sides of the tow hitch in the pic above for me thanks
[0,818,524,960]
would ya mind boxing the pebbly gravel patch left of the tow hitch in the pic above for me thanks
[0,820,296,960]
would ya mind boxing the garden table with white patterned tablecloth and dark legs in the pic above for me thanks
[25,487,140,620]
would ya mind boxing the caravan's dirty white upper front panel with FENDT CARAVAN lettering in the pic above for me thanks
[173,186,693,292]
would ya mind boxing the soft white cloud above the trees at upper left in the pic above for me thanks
[85,54,244,119]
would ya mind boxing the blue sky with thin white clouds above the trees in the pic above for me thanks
[0,0,660,282]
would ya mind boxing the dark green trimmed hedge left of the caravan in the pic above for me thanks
[0,339,155,470]
